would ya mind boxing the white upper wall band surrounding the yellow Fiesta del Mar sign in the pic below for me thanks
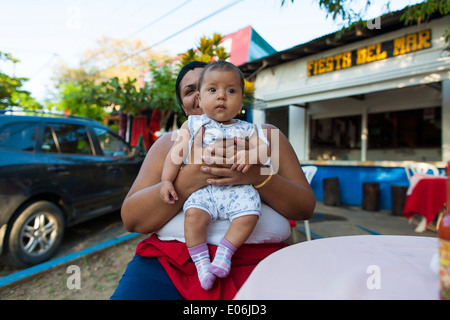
[255,16,450,107]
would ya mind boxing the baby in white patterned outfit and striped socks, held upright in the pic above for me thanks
[161,60,268,290]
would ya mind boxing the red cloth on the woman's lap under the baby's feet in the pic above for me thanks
[136,235,287,300]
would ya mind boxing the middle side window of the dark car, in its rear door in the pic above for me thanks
[41,123,92,155]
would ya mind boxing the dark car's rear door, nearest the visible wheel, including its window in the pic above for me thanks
[40,121,112,220]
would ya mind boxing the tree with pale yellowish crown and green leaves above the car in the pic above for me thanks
[53,37,173,120]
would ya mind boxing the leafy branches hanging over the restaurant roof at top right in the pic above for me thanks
[281,0,450,42]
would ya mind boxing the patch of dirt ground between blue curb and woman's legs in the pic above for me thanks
[0,235,147,300]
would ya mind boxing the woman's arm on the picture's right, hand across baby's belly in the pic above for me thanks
[201,124,316,220]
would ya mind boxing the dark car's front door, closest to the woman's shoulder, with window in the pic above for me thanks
[91,126,143,206]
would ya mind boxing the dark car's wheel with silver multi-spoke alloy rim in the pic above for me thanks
[6,201,65,268]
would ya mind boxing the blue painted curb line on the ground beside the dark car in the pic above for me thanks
[0,233,140,288]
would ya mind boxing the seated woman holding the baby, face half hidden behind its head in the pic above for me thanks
[111,62,315,299]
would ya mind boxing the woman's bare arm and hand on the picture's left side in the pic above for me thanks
[121,130,210,234]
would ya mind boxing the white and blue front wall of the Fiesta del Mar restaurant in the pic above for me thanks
[251,16,450,209]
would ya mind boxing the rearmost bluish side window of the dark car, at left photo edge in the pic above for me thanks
[0,122,39,151]
